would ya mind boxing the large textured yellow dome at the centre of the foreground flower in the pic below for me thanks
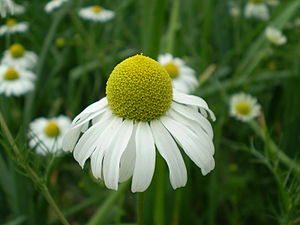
[106,55,173,121]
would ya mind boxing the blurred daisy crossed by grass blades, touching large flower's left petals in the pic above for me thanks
[29,115,71,155]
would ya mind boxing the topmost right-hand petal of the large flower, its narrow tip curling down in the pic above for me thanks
[173,92,216,120]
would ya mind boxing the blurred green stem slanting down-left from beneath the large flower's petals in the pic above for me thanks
[87,182,129,225]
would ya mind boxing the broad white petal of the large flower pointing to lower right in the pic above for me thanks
[161,117,215,175]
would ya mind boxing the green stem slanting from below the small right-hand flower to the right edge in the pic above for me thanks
[249,121,300,173]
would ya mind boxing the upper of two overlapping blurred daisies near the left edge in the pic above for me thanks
[2,43,37,69]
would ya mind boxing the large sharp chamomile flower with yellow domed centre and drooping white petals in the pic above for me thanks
[63,55,215,192]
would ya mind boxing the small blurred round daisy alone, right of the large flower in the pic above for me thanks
[230,93,260,122]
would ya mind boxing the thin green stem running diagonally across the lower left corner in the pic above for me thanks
[0,112,70,225]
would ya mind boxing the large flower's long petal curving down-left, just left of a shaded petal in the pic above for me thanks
[103,120,133,190]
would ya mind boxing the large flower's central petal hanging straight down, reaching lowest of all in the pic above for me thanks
[131,122,155,192]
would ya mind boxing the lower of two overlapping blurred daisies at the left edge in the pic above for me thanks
[0,65,35,96]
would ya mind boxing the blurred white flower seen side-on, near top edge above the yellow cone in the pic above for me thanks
[79,5,115,22]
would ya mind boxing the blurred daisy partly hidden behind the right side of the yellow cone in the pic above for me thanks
[158,53,198,93]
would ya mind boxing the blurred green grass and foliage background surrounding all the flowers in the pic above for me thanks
[0,0,300,225]
